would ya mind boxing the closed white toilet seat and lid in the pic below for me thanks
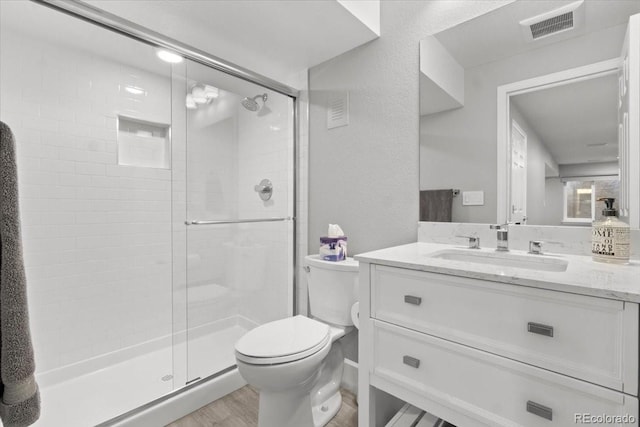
[235,315,331,365]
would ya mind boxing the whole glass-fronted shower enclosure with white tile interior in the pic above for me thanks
[0,1,295,427]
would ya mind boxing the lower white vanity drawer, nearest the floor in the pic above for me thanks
[371,321,638,427]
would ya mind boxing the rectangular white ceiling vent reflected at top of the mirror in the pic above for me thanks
[520,0,584,42]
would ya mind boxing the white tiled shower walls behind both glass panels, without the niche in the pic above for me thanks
[0,19,306,385]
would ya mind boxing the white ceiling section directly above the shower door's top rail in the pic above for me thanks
[82,0,379,87]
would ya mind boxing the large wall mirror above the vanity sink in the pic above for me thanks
[420,1,640,227]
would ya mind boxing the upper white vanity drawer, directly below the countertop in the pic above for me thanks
[371,265,639,396]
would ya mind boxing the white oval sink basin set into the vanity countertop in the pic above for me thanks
[428,249,567,271]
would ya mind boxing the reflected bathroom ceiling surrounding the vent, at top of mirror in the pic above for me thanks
[434,0,640,68]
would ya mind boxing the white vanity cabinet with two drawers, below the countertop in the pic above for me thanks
[359,259,639,427]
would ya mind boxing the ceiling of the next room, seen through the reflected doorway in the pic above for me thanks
[511,73,618,164]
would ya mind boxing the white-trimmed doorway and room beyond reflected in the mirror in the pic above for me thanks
[498,60,620,225]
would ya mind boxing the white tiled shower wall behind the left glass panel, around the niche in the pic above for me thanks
[0,29,171,372]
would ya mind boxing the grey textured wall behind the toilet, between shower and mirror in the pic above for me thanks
[308,1,505,254]
